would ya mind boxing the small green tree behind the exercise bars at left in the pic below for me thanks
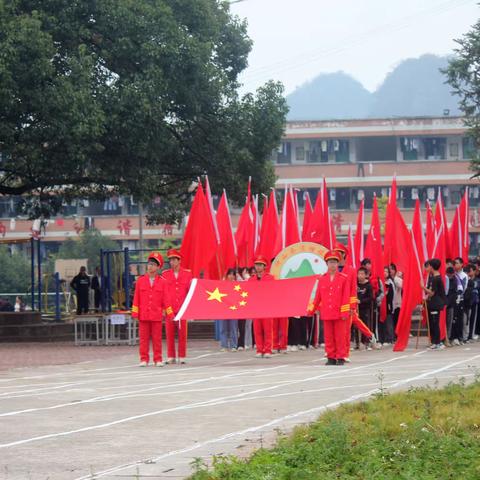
[55,229,119,273]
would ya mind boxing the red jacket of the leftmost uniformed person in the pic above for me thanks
[132,275,173,322]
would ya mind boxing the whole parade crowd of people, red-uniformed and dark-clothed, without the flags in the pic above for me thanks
[132,244,480,366]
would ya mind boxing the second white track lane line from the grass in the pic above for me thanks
[0,355,409,448]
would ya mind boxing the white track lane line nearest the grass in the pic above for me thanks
[70,355,480,480]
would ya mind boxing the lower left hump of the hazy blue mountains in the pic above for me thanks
[287,72,372,120]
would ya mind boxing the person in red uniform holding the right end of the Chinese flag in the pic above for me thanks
[310,250,350,365]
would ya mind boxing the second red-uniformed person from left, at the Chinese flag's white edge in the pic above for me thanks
[162,249,192,363]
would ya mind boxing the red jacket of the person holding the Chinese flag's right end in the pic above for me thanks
[313,272,350,320]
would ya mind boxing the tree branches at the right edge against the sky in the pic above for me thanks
[443,21,480,177]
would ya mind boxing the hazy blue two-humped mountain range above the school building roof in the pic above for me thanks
[287,54,460,120]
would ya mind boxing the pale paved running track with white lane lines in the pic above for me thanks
[0,342,480,480]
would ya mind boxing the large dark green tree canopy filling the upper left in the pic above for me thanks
[0,0,287,220]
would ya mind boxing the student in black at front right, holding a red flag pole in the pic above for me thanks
[423,258,447,350]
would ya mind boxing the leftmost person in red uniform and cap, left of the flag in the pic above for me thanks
[132,252,173,367]
